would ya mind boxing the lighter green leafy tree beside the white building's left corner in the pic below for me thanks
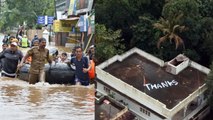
[95,24,124,63]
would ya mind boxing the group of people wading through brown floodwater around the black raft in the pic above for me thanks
[0,35,95,86]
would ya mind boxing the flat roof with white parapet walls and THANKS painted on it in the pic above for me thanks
[96,48,210,117]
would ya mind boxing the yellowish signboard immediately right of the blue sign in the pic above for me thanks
[53,19,78,32]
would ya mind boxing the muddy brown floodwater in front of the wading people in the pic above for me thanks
[0,37,95,120]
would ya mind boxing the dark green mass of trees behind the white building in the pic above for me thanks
[95,0,213,67]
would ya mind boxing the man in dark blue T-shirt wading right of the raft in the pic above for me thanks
[70,46,91,86]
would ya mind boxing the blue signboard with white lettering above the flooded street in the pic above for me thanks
[37,16,54,25]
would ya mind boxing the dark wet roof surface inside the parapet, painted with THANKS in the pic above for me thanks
[104,54,206,109]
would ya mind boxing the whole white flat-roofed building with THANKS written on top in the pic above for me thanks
[96,48,210,120]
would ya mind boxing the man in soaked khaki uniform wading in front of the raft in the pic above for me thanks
[19,38,52,84]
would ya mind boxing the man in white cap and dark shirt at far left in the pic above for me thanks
[0,42,23,78]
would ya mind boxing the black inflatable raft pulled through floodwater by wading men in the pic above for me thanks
[18,63,75,85]
